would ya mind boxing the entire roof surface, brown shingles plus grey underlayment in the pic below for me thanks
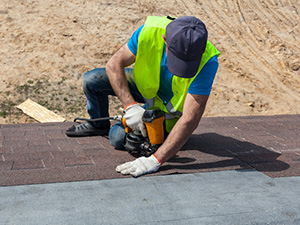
[0,115,300,225]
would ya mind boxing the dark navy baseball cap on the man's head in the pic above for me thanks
[166,16,208,78]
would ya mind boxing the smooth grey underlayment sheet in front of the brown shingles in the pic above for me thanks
[0,170,300,225]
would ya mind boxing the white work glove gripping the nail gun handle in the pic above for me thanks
[124,103,147,137]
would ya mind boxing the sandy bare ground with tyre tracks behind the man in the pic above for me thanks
[0,0,300,123]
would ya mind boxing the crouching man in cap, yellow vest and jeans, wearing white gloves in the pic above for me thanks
[66,16,220,177]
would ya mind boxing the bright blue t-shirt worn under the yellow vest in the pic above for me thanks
[127,25,219,102]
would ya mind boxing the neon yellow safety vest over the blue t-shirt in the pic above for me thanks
[133,16,220,132]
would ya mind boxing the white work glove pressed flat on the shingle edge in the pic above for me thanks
[116,155,161,177]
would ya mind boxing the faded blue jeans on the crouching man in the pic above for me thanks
[82,68,144,149]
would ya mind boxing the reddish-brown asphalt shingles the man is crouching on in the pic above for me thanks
[0,115,300,186]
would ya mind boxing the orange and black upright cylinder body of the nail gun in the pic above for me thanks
[143,107,165,145]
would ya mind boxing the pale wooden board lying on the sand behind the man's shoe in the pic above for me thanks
[17,99,65,123]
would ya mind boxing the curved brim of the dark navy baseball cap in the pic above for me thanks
[167,51,201,78]
